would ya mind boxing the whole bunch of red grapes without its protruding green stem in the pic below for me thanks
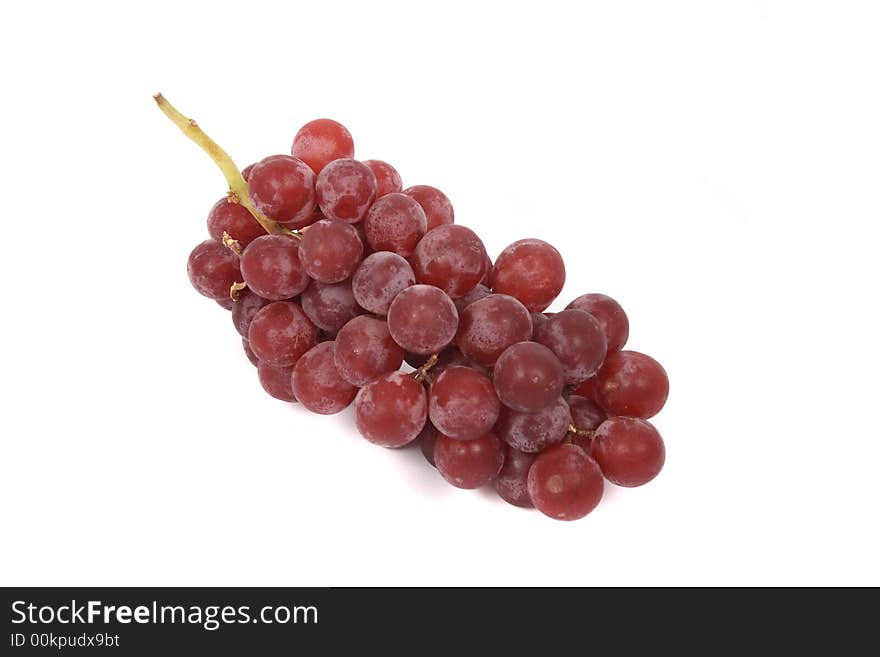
[188,119,669,520]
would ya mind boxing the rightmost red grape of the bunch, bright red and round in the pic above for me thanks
[593,351,669,419]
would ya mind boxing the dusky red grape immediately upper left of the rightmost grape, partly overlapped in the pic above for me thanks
[534,310,606,385]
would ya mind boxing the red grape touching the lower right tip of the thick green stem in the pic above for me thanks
[299,219,364,283]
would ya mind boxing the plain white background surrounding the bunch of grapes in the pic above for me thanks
[0,0,880,585]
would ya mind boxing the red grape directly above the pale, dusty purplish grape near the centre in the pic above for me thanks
[364,194,427,258]
